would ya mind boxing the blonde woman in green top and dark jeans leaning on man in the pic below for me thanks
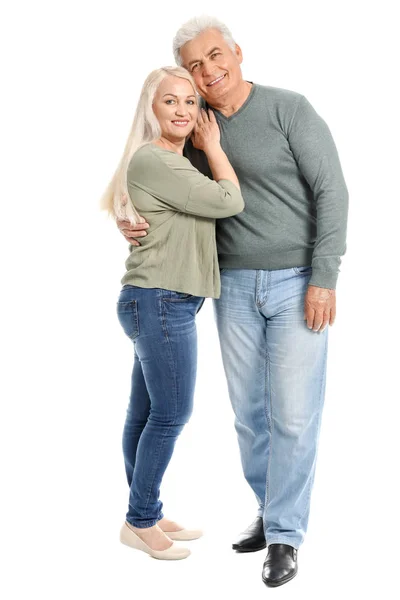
[103,67,244,559]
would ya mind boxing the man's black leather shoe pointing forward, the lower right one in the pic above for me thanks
[262,544,297,587]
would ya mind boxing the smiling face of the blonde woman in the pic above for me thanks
[153,75,199,141]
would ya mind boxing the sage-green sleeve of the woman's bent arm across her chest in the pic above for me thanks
[128,148,244,219]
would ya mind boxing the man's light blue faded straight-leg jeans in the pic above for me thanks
[214,267,328,548]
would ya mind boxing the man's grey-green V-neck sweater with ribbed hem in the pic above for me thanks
[184,84,348,289]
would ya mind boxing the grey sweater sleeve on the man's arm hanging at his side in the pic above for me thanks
[288,96,348,289]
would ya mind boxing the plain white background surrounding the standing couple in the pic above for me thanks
[0,0,400,600]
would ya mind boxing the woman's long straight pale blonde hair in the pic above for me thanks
[101,67,197,225]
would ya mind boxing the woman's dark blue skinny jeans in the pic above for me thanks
[117,285,204,528]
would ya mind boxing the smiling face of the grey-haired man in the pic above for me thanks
[181,29,242,106]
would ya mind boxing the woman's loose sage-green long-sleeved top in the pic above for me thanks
[121,144,244,298]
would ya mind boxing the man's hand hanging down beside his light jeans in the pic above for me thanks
[304,285,336,332]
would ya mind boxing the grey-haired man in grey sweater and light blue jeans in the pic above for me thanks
[119,17,348,586]
